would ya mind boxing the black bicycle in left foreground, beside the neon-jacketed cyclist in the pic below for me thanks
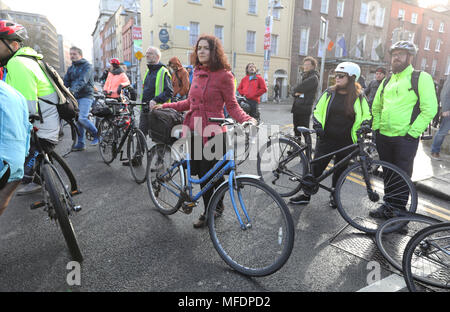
[30,115,83,262]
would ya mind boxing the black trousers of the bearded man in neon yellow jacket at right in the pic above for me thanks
[376,133,419,209]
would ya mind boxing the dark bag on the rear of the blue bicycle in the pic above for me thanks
[147,108,184,145]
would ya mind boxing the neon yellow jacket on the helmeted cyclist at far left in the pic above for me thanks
[5,47,60,144]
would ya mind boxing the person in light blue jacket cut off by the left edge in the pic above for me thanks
[0,80,32,215]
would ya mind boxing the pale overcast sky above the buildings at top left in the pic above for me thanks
[3,0,99,62]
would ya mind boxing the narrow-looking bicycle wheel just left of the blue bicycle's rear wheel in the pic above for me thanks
[127,128,148,184]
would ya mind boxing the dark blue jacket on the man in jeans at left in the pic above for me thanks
[64,58,94,99]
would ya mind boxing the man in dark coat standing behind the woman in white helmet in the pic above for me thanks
[291,56,319,139]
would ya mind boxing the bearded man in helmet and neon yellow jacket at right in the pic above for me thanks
[370,41,438,218]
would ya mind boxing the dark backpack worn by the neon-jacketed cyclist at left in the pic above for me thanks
[18,55,80,123]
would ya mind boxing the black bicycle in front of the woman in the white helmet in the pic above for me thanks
[257,127,417,234]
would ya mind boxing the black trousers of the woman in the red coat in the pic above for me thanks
[190,133,227,214]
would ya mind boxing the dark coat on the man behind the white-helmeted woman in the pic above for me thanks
[291,71,319,114]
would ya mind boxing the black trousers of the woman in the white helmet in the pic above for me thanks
[311,138,355,188]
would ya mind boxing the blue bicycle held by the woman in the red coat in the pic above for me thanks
[147,118,294,276]
